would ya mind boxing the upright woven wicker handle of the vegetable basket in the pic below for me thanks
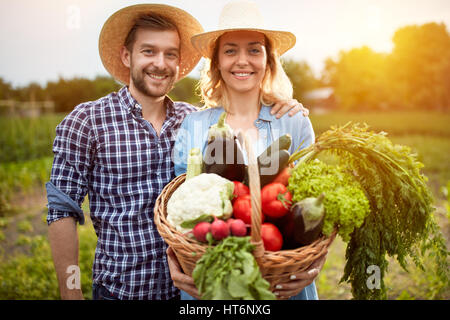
[243,134,264,258]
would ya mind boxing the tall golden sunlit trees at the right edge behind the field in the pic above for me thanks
[322,23,450,111]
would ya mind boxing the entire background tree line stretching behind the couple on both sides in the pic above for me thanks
[0,23,450,112]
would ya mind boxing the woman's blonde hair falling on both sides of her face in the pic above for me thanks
[199,36,293,110]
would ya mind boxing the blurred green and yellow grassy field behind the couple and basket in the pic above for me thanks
[0,112,450,300]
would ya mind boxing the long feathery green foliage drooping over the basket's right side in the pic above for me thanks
[290,123,449,299]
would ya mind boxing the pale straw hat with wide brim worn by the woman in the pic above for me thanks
[191,1,296,58]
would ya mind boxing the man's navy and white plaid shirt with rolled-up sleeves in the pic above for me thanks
[47,87,196,300]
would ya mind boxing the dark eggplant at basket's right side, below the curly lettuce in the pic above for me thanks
[279,193,325,249]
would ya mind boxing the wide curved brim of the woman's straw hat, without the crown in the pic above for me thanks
[191,28,296,59]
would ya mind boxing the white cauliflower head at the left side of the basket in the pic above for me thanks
[167,173,234,232]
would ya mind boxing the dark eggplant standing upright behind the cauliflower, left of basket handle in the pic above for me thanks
[203,112,246,181]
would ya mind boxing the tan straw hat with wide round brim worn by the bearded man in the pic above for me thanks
[98,4,203,85]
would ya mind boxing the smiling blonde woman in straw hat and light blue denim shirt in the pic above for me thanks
[168,2,325,299]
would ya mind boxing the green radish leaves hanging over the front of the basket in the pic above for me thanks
[192,236,276,300]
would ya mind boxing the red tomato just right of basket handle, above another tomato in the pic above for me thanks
[261,182,292,218]
